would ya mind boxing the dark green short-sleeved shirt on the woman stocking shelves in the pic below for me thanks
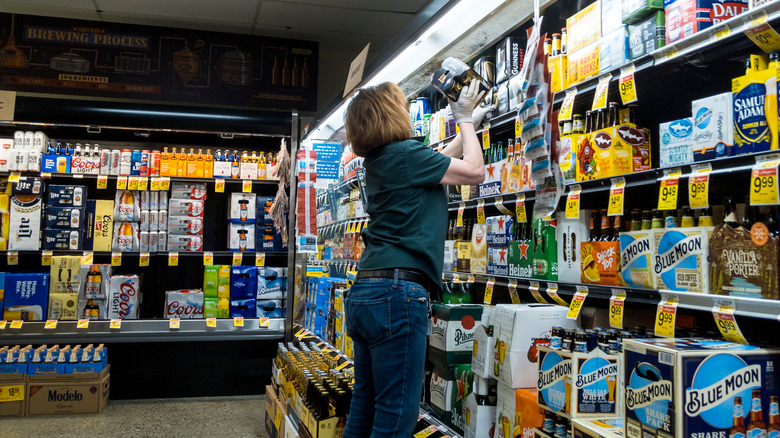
[358,140,450,287]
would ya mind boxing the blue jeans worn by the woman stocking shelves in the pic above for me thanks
[344,271,428,438]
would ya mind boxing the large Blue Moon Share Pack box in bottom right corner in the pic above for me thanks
[623,338,780,438]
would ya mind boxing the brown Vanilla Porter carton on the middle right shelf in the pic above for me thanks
[708,225,780,300]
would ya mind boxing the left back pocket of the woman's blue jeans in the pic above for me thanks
[346,297,391,344]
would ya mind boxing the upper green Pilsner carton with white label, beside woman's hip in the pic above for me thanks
[428,303,482,366]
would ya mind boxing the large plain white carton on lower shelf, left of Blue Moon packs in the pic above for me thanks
[490,304,577,388]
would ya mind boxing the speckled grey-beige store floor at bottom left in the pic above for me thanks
[0,395,268,438]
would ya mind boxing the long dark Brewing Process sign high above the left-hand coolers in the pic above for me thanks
[0,14,319,111]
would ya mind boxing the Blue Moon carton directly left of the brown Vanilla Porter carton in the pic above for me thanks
[653,227,712,293]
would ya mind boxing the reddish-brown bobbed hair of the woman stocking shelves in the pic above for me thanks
[345,82,412,157]
